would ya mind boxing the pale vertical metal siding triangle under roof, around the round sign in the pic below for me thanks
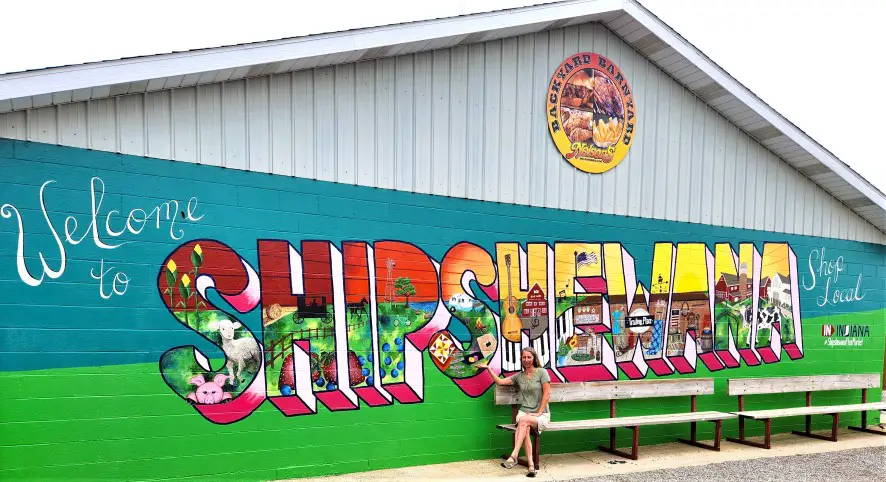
[0,24,886,244]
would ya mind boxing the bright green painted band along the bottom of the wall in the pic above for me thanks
[0,310,886,480]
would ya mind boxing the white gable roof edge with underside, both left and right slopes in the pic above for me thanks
[0,0,886,233]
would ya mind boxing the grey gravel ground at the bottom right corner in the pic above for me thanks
[571,447,886,482]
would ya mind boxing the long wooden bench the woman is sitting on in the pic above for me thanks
[495,378,736,469]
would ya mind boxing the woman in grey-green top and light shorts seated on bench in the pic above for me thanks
[477,347,551,477]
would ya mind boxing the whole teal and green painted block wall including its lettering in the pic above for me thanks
[0,140,886,480]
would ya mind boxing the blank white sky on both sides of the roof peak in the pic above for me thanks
[0,0,886,192]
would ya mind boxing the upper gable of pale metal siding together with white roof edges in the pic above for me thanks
[0,1,886,243]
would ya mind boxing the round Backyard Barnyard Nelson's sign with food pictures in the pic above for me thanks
[547,52,636,174]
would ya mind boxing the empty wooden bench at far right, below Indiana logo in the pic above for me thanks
[726,373,886,449]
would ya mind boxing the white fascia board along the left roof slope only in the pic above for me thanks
[0,0,625,102]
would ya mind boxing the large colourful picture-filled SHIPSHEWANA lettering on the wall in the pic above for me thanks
[157,235,803,423]
